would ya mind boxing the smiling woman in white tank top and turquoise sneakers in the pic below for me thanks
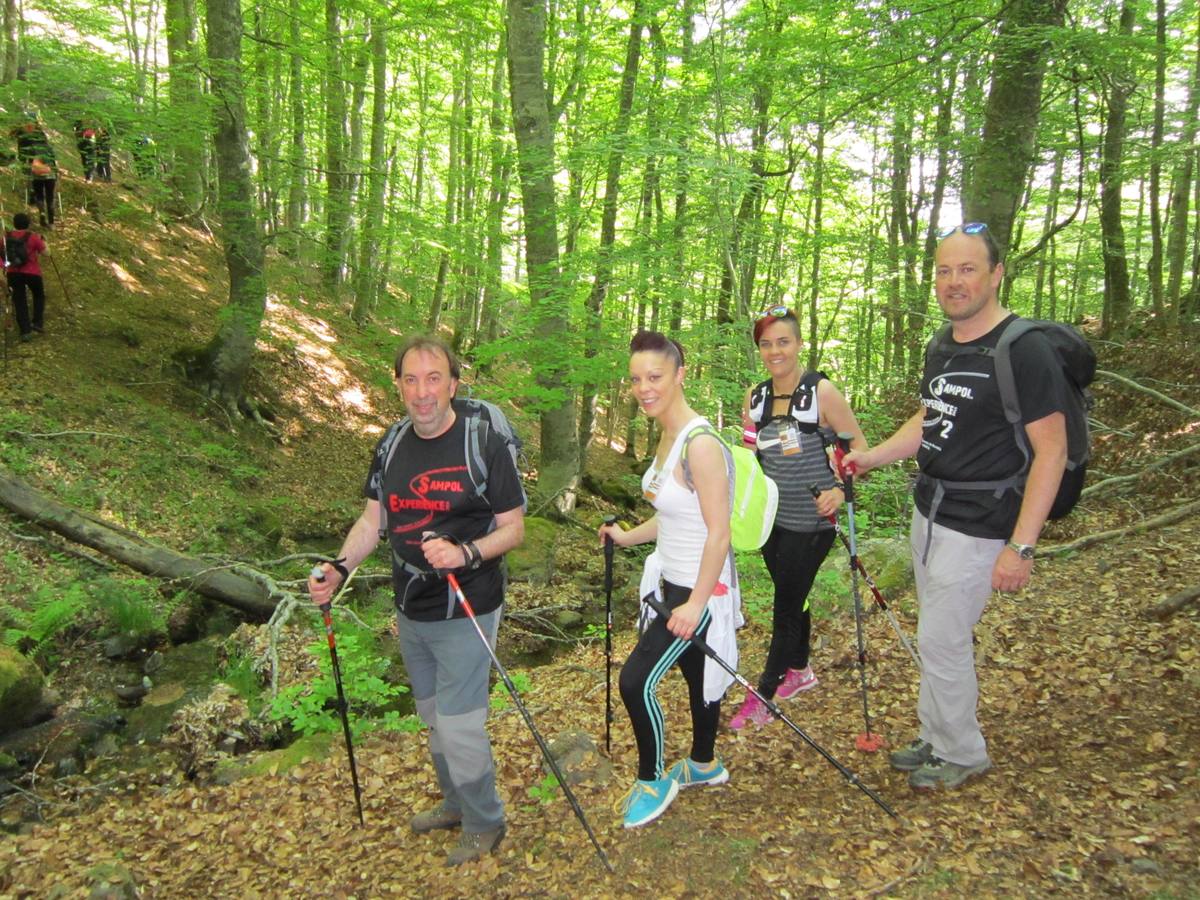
[600,331,742,828]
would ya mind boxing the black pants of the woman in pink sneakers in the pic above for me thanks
[758,528,834,700]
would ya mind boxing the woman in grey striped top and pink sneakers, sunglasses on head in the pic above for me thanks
[730,306,866,731]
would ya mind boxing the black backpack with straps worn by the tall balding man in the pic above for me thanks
[925,318,1096,518]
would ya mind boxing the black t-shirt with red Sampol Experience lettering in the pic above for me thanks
[364,415,524,622]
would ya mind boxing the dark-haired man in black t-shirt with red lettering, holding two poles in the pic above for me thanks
[308,336,524,865]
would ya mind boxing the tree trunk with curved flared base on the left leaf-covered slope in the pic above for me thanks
[200,0,266,410]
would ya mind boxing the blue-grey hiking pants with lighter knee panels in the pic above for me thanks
[396,606,504,832]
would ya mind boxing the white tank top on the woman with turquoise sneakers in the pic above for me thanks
[642,415,708,588]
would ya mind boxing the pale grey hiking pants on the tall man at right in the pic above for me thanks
[908,510,1004,766]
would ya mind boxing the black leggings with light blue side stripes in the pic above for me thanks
[619,582,721,781]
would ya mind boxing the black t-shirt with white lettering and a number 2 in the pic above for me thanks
[914,316,1066,540]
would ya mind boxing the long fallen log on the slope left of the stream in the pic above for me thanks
[0,472,276,620]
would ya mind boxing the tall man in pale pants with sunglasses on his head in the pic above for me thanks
[845,222,1067,790]
